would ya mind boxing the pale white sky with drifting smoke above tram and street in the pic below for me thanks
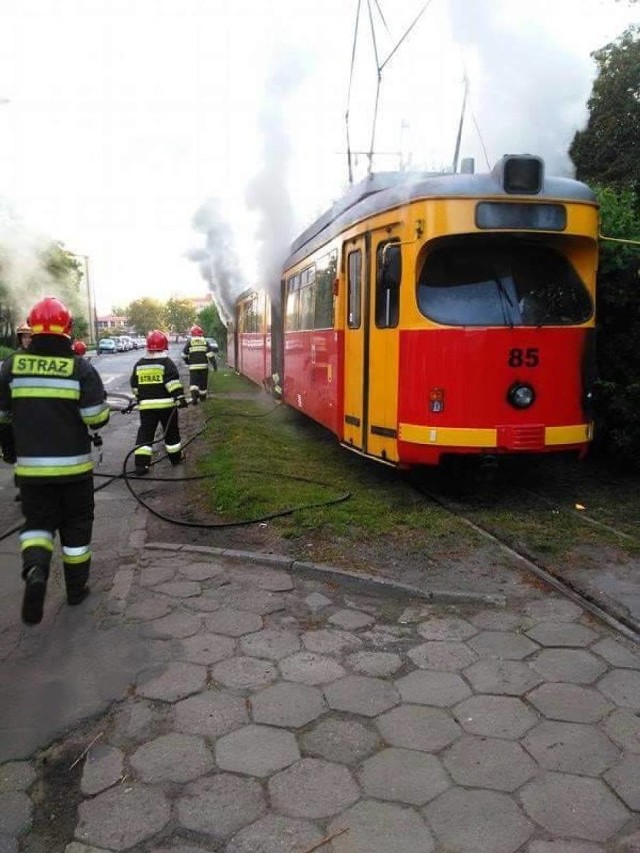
[0,0,638,314]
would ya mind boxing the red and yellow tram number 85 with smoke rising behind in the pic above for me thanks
[232,156,598,467]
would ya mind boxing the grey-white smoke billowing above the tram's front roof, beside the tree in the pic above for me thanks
[449,0,594,175]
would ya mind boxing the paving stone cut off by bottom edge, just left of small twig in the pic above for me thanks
[225,814,324,853]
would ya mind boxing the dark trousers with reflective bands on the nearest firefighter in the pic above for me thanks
[20,476,94,597]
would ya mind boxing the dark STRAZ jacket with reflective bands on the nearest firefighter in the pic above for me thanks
[0,335,110,483]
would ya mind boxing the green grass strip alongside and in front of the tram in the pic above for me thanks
[189,368,640,563]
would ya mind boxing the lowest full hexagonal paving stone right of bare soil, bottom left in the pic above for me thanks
[75,784,171,850]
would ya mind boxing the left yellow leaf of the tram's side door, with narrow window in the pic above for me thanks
[343,237,368,450]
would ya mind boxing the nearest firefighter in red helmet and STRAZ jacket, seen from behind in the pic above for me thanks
[0,296,109,625]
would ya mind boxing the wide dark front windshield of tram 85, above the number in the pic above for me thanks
[417,235,593,326]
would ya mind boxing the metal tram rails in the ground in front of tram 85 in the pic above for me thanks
[414,483,640,644]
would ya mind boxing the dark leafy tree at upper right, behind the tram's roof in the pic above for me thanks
[569,26,640,192]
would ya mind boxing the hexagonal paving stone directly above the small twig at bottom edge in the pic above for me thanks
[269,758,360,818]
